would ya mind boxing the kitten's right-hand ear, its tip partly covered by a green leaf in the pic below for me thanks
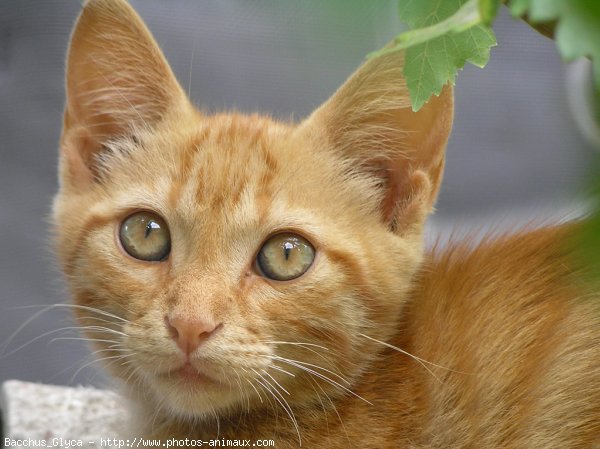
[300,52,454,234]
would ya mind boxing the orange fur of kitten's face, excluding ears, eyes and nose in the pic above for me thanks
[57,111,418,414]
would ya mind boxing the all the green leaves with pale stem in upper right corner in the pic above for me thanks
[369,0,600,111]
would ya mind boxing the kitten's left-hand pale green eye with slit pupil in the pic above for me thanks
[119,212,171,262]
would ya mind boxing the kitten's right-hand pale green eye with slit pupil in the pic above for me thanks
[256,233,315,281]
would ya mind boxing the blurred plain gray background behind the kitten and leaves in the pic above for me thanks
[0,0,597,384]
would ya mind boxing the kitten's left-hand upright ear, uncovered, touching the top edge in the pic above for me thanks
[61,0,187,190]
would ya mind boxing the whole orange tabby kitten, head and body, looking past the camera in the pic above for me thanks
[54,0,600,449]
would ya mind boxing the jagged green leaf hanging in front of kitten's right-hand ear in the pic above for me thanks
[399,0,496,111]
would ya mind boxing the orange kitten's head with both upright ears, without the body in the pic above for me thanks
[54,0,452,418]
